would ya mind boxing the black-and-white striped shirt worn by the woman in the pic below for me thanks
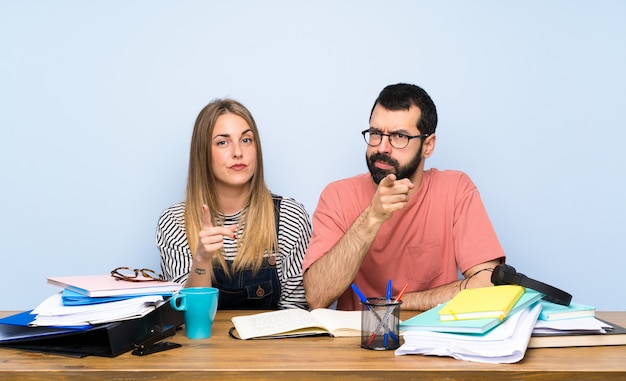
[156,198,311,309]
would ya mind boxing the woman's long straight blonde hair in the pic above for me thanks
[185,99,278,273]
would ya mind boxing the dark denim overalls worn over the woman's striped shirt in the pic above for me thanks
[213,196,281,310]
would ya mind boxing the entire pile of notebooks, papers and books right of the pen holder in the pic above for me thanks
[396,285,626,363]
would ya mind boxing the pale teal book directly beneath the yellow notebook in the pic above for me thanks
[400,288,543,334]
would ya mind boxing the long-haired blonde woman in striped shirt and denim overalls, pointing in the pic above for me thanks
[156,99,311,309]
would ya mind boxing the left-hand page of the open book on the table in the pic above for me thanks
[232,308,327,340]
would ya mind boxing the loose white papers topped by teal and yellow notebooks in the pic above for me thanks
[396,285,543,363]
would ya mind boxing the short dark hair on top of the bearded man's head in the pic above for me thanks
[370,83,437,134]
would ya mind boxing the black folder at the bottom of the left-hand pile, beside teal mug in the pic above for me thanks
[0,302,184,357]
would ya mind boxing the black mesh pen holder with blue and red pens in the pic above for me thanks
[361,298,402,350]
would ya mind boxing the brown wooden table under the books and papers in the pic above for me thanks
[0,311,626,381]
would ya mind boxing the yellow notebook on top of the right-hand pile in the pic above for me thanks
[439,284,525,321]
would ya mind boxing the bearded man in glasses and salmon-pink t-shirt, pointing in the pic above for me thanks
[303,83,505,311]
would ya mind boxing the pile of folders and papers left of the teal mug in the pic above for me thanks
[0,275,183,357]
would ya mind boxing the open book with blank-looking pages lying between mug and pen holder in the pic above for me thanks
[231,308,361,340]
